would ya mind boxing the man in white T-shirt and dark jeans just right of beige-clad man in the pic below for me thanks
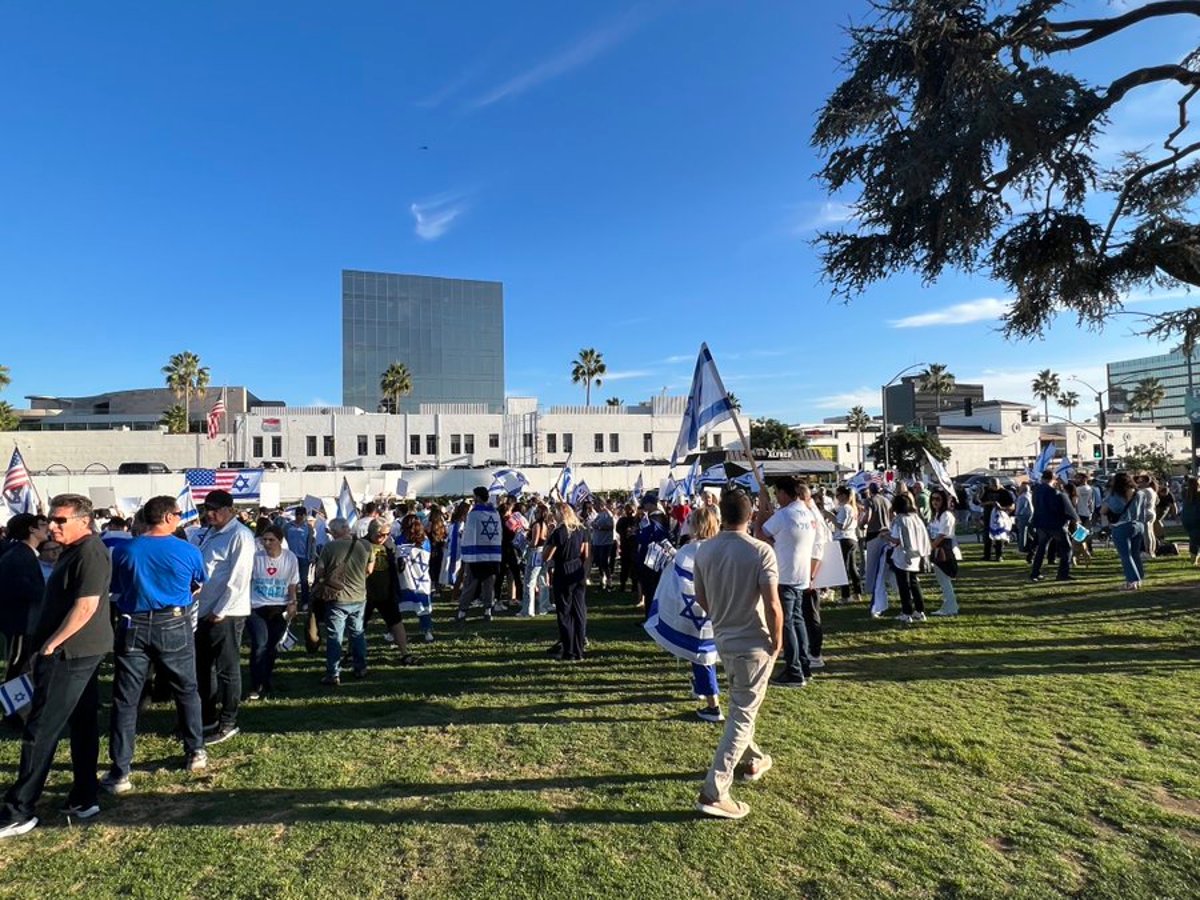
[757,476,824,688]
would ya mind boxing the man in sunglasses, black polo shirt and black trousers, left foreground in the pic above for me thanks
[0,493,113,838]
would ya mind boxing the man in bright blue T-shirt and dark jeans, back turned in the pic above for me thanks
[101,497,208,793]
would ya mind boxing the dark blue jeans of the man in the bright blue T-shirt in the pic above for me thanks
[108,606,204,775]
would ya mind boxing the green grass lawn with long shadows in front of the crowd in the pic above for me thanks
[0,544,1200,898]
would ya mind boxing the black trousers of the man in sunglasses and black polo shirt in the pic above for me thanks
[4,649,104,818]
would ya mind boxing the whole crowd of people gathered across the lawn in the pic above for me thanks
[0,472,1200,838]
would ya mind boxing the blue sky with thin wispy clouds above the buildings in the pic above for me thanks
[0,0,1200,422]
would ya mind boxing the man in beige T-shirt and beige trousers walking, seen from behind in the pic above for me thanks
[695,491,784,818]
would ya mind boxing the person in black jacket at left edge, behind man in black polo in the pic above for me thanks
[0,512,48,682]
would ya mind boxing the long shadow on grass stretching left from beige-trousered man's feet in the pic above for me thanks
[51,772,703,828]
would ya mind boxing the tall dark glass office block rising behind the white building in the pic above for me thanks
[342,270,504,413]
